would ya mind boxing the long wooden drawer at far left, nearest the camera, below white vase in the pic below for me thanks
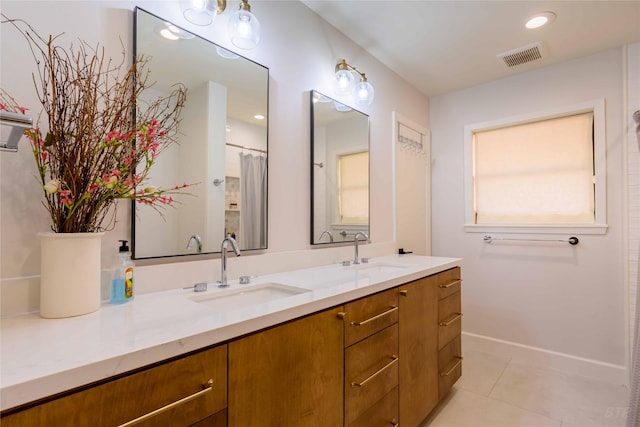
[2,345,227,427]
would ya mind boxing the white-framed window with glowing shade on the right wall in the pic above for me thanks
[465,102,606,233]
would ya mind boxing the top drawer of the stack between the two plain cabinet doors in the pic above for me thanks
[344,289,398,347]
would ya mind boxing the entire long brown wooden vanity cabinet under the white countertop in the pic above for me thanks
[0,267,462,427]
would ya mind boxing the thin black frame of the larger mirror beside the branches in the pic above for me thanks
[130,6,270,260]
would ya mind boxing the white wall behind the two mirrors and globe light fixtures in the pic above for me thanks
[0,0,428,316]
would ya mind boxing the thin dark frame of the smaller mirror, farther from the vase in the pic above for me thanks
[309,90,371,246]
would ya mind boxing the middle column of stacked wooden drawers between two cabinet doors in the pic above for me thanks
[344,289,399,427]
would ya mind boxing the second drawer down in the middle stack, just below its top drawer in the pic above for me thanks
[345,324,398,425]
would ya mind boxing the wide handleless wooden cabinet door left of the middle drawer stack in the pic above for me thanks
[228,307,344,427]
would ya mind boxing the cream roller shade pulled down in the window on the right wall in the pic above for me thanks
[474,113,595,224]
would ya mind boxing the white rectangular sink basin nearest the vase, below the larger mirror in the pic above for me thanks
[191,283,309,310]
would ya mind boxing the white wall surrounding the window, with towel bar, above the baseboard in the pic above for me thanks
[430,49,637,378]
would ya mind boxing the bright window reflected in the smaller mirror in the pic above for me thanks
[338,151,369,224]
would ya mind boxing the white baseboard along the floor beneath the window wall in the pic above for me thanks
[462,332,629,386]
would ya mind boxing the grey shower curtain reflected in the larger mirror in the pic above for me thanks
[240,153,267,248]
